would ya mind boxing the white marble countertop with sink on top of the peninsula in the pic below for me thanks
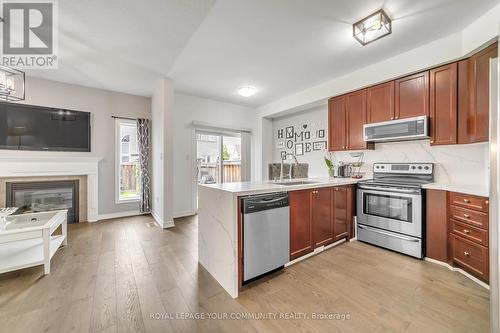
[199,177,366,196]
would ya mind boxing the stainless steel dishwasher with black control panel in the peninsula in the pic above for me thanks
[241,193,290,282]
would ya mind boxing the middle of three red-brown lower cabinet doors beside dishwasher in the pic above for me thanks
[312,188,333,247]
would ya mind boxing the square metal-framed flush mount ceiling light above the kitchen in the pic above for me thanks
[352,9,392,46]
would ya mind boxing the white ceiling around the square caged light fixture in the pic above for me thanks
[29,0,500,106]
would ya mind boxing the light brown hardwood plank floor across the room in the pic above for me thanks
[0,216,489,333]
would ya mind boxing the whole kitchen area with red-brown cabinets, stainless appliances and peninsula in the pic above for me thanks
[198,32,498,328]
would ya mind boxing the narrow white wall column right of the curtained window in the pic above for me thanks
[151,79,174,228]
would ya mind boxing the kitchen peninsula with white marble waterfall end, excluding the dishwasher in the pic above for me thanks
[198,178,358,298]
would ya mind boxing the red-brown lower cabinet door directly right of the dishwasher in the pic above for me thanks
[288,190,314,260]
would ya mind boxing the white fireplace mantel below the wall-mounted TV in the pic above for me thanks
[0,155,102,222]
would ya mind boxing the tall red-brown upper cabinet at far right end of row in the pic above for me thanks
[458,43,498,143]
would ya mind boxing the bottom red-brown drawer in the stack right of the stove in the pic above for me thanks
[451,235,488,281]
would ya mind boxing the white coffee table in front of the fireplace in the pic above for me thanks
[0,210,68,274]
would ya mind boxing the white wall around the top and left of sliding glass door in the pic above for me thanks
[173,93,256,216]
